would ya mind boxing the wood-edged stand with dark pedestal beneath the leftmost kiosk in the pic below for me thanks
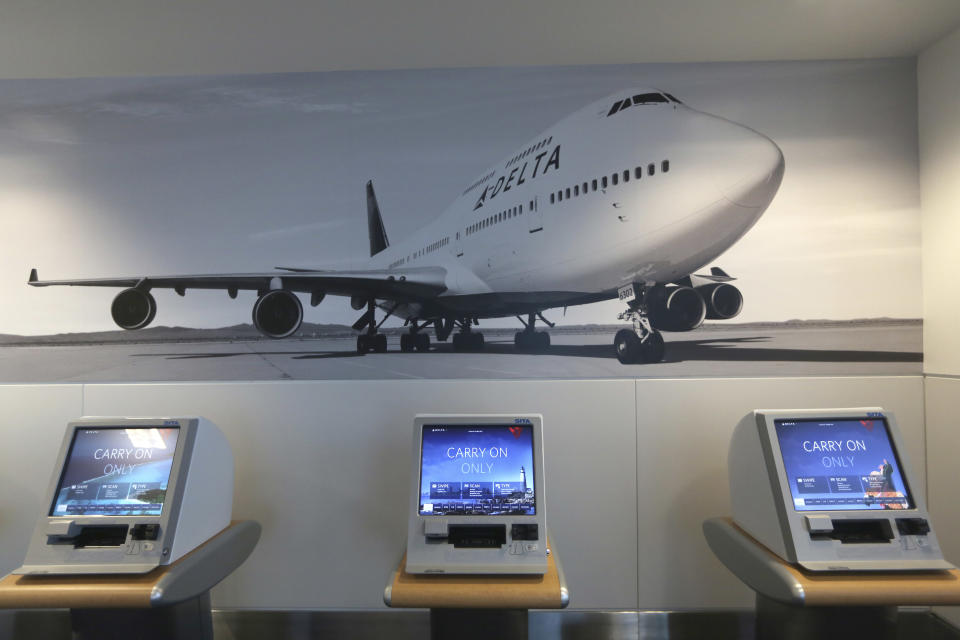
[0,520,260,640]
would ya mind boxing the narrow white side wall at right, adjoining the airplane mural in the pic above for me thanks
[917,22,960,625]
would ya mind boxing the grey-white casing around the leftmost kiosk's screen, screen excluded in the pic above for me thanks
[14,417,233,574]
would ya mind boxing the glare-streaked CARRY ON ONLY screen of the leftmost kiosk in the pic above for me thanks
[50,427,180,516]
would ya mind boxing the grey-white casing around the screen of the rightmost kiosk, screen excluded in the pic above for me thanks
[728,407,953,571]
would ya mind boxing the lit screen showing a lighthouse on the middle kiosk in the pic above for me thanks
[419,424,537,516]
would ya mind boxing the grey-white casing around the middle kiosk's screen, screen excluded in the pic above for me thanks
[406,414,547,574]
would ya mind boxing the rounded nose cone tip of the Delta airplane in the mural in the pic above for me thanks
[718,130,784,209]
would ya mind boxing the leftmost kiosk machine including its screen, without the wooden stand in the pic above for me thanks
[14,418,233,574]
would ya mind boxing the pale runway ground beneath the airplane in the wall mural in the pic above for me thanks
[0,324,923,383]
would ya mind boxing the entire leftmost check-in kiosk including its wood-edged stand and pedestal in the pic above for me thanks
[0,418,260,640]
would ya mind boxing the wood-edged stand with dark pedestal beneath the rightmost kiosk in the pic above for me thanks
[703,518,960,640]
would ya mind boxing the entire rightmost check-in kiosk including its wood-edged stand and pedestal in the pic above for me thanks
[703,407,960,640]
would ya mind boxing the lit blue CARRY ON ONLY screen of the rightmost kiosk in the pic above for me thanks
[774,418,913,511]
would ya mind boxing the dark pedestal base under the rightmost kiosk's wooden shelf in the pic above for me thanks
[756,593,897,640]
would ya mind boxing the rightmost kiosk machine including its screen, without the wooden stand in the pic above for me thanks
[729,407,953,571]
